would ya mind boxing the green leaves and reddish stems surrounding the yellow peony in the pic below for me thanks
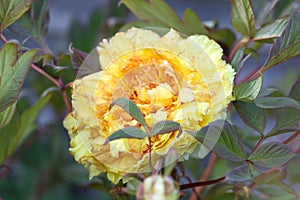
[0,0,300,199]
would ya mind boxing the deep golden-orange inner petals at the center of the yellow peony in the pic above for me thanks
[95,49,208,153]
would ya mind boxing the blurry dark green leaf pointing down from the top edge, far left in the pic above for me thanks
[18,0,50,40]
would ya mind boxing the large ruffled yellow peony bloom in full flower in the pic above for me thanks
[64,28,235,183]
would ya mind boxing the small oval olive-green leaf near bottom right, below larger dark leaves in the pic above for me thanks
[253,168,287,185]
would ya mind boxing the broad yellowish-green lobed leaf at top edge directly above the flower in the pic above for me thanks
[121,0,207,35]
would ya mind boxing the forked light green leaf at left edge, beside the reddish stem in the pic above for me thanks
[0,43,37,112]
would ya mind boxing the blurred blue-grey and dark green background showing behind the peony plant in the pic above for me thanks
[0,0,300,200]
